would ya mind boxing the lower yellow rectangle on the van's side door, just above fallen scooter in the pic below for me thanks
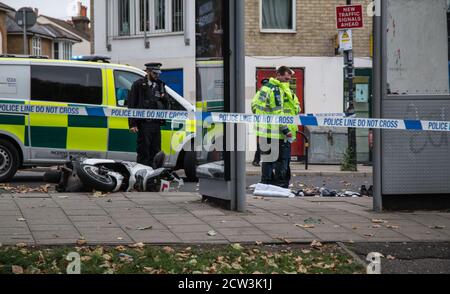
[67,127,108,152]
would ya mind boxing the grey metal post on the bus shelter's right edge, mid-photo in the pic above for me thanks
[234,0,247,212]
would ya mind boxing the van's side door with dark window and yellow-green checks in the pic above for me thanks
[30,64,108,163]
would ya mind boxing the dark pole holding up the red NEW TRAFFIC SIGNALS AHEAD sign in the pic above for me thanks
[344,0,357,171]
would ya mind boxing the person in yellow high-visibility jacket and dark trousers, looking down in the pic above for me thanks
[252,66,298,188]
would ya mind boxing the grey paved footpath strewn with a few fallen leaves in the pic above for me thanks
[0,193,450,245]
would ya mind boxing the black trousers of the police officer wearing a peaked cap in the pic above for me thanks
[137,122,161,167]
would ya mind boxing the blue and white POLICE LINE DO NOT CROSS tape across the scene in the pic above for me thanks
[0,103,450,132]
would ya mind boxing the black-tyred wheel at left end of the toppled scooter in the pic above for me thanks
[76,164,117,193]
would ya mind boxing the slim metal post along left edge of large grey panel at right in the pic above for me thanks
[373,3,385,212]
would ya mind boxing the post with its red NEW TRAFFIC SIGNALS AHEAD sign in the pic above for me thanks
[336,0,364,171]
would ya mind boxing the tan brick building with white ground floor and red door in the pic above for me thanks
[245,0,372,163]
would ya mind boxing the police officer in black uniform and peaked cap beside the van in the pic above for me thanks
[128,63,169,167]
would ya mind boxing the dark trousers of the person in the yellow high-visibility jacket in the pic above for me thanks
[261,140,291,188]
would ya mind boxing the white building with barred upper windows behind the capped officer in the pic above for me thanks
[91,0,196,102]
